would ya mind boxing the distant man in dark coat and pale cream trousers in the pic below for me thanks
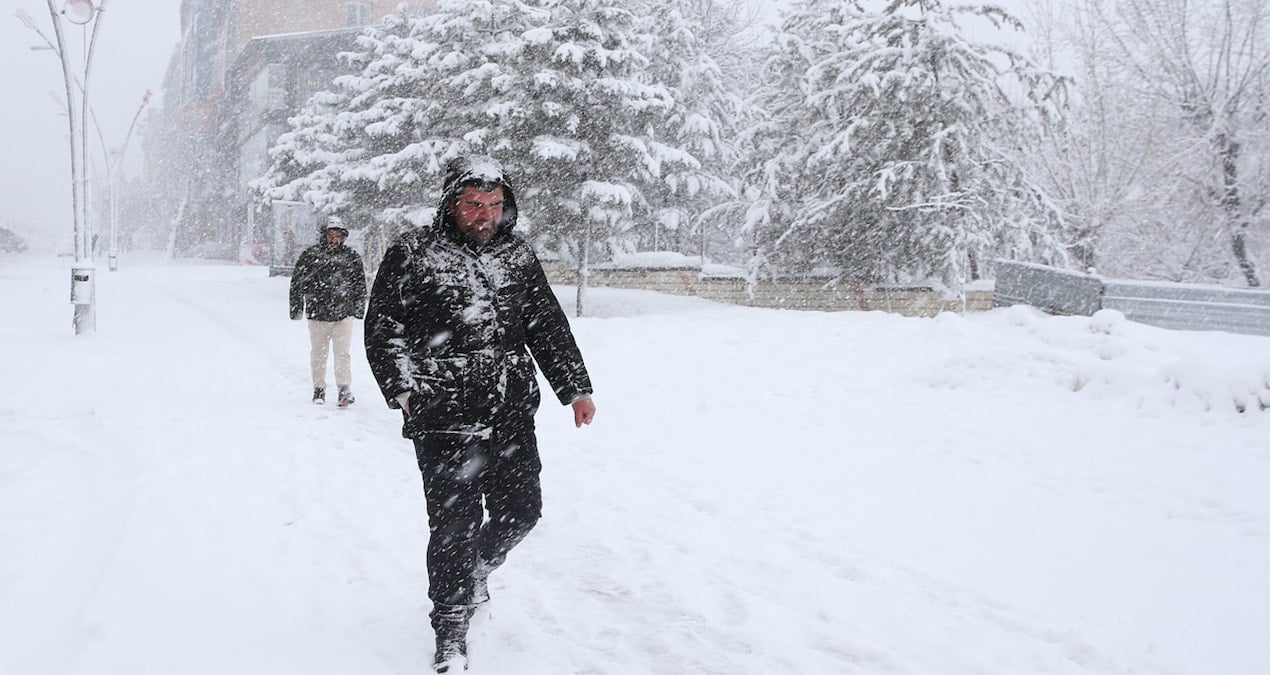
[291,220,366,408]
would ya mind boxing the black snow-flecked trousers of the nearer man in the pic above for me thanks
[414,418,542,605]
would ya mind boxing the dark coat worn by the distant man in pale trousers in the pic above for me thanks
[291,243,366,322]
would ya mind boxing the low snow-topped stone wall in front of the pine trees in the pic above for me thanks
[545,263,992,317]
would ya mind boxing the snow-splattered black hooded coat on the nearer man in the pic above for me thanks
[366,162,591,439]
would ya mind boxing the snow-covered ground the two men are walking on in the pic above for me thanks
[0,256,1270,675]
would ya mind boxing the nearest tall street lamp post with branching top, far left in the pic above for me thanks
[17,0,107,334]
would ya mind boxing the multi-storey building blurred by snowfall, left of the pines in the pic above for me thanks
[144,0,426,264]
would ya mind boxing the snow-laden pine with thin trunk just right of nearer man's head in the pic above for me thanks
[499,0,679,279]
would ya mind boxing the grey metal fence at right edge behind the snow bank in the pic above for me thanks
[993,261,1270,336]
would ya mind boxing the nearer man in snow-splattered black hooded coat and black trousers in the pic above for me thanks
[366,156,596,672]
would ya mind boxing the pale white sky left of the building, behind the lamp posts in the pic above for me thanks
[0,0,180,236]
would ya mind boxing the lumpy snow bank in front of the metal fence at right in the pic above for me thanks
[917,305,1270,413]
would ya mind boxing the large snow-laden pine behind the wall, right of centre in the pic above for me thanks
[748,0,1063,287]
